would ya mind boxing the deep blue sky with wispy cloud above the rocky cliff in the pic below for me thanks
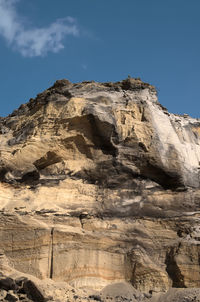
[0,0,200,118]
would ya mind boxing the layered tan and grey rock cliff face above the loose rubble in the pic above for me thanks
[0,78,200,298]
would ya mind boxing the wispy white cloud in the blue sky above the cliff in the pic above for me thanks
[0,0,79,57]
